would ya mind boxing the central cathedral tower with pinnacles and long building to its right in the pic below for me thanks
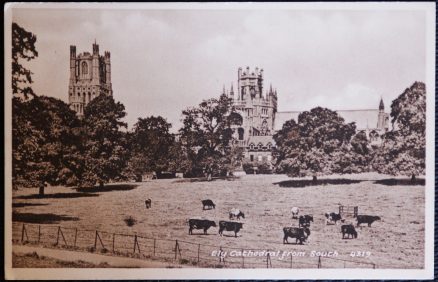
[223,67,389,162]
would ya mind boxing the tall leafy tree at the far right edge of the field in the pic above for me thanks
[373,82,426,182]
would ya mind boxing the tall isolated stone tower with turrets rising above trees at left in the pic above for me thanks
[68,42,113,116]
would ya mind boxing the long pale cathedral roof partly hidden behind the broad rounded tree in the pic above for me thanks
[274,109,379,131]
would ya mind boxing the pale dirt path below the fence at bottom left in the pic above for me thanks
[14,245,182,268]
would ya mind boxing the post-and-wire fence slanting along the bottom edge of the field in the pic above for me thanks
[12,222,381,268]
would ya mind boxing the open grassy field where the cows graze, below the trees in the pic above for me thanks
[13,174,425,268]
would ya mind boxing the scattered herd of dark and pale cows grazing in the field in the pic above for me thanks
[145,199,381,244]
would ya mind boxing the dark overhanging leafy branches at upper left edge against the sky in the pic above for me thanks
[12,23,38,98]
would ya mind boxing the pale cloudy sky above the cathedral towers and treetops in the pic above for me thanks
[12,5,426,131]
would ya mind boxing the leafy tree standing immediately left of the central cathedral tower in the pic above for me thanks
[180,95,241,180]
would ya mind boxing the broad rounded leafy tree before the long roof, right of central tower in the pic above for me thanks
[274,107,356,181]
